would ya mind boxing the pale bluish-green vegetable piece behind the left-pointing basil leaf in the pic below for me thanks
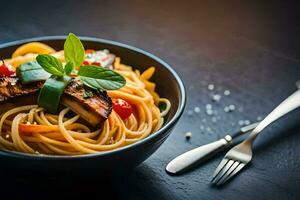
[17,61,51,84]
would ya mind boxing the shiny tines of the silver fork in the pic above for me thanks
[211,158,245,185]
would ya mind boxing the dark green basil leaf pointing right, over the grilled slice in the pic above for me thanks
[78,65,126,91]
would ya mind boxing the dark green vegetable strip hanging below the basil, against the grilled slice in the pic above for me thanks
[38,76,72,114]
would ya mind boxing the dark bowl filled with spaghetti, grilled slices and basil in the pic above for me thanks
[0,34,185,171]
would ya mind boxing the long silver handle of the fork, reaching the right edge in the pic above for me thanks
[246,90,300,142]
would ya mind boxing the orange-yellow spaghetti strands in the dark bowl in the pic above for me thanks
[0,42,171,155]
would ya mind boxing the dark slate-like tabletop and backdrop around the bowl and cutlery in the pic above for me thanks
[0,0,300,199]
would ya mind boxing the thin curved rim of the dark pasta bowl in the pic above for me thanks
[0,35,186,160]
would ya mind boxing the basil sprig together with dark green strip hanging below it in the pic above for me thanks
[36,33,126,113]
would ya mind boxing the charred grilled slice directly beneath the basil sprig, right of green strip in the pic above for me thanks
[61,80,112,126]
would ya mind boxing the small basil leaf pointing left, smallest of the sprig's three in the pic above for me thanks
[36,54,64,76]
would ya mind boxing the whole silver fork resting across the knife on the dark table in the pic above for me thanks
[211,89,300,185]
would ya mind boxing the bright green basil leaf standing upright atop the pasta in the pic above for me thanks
[64,33,84,67]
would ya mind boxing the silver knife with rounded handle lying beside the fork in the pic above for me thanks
[166,122,259,174]
